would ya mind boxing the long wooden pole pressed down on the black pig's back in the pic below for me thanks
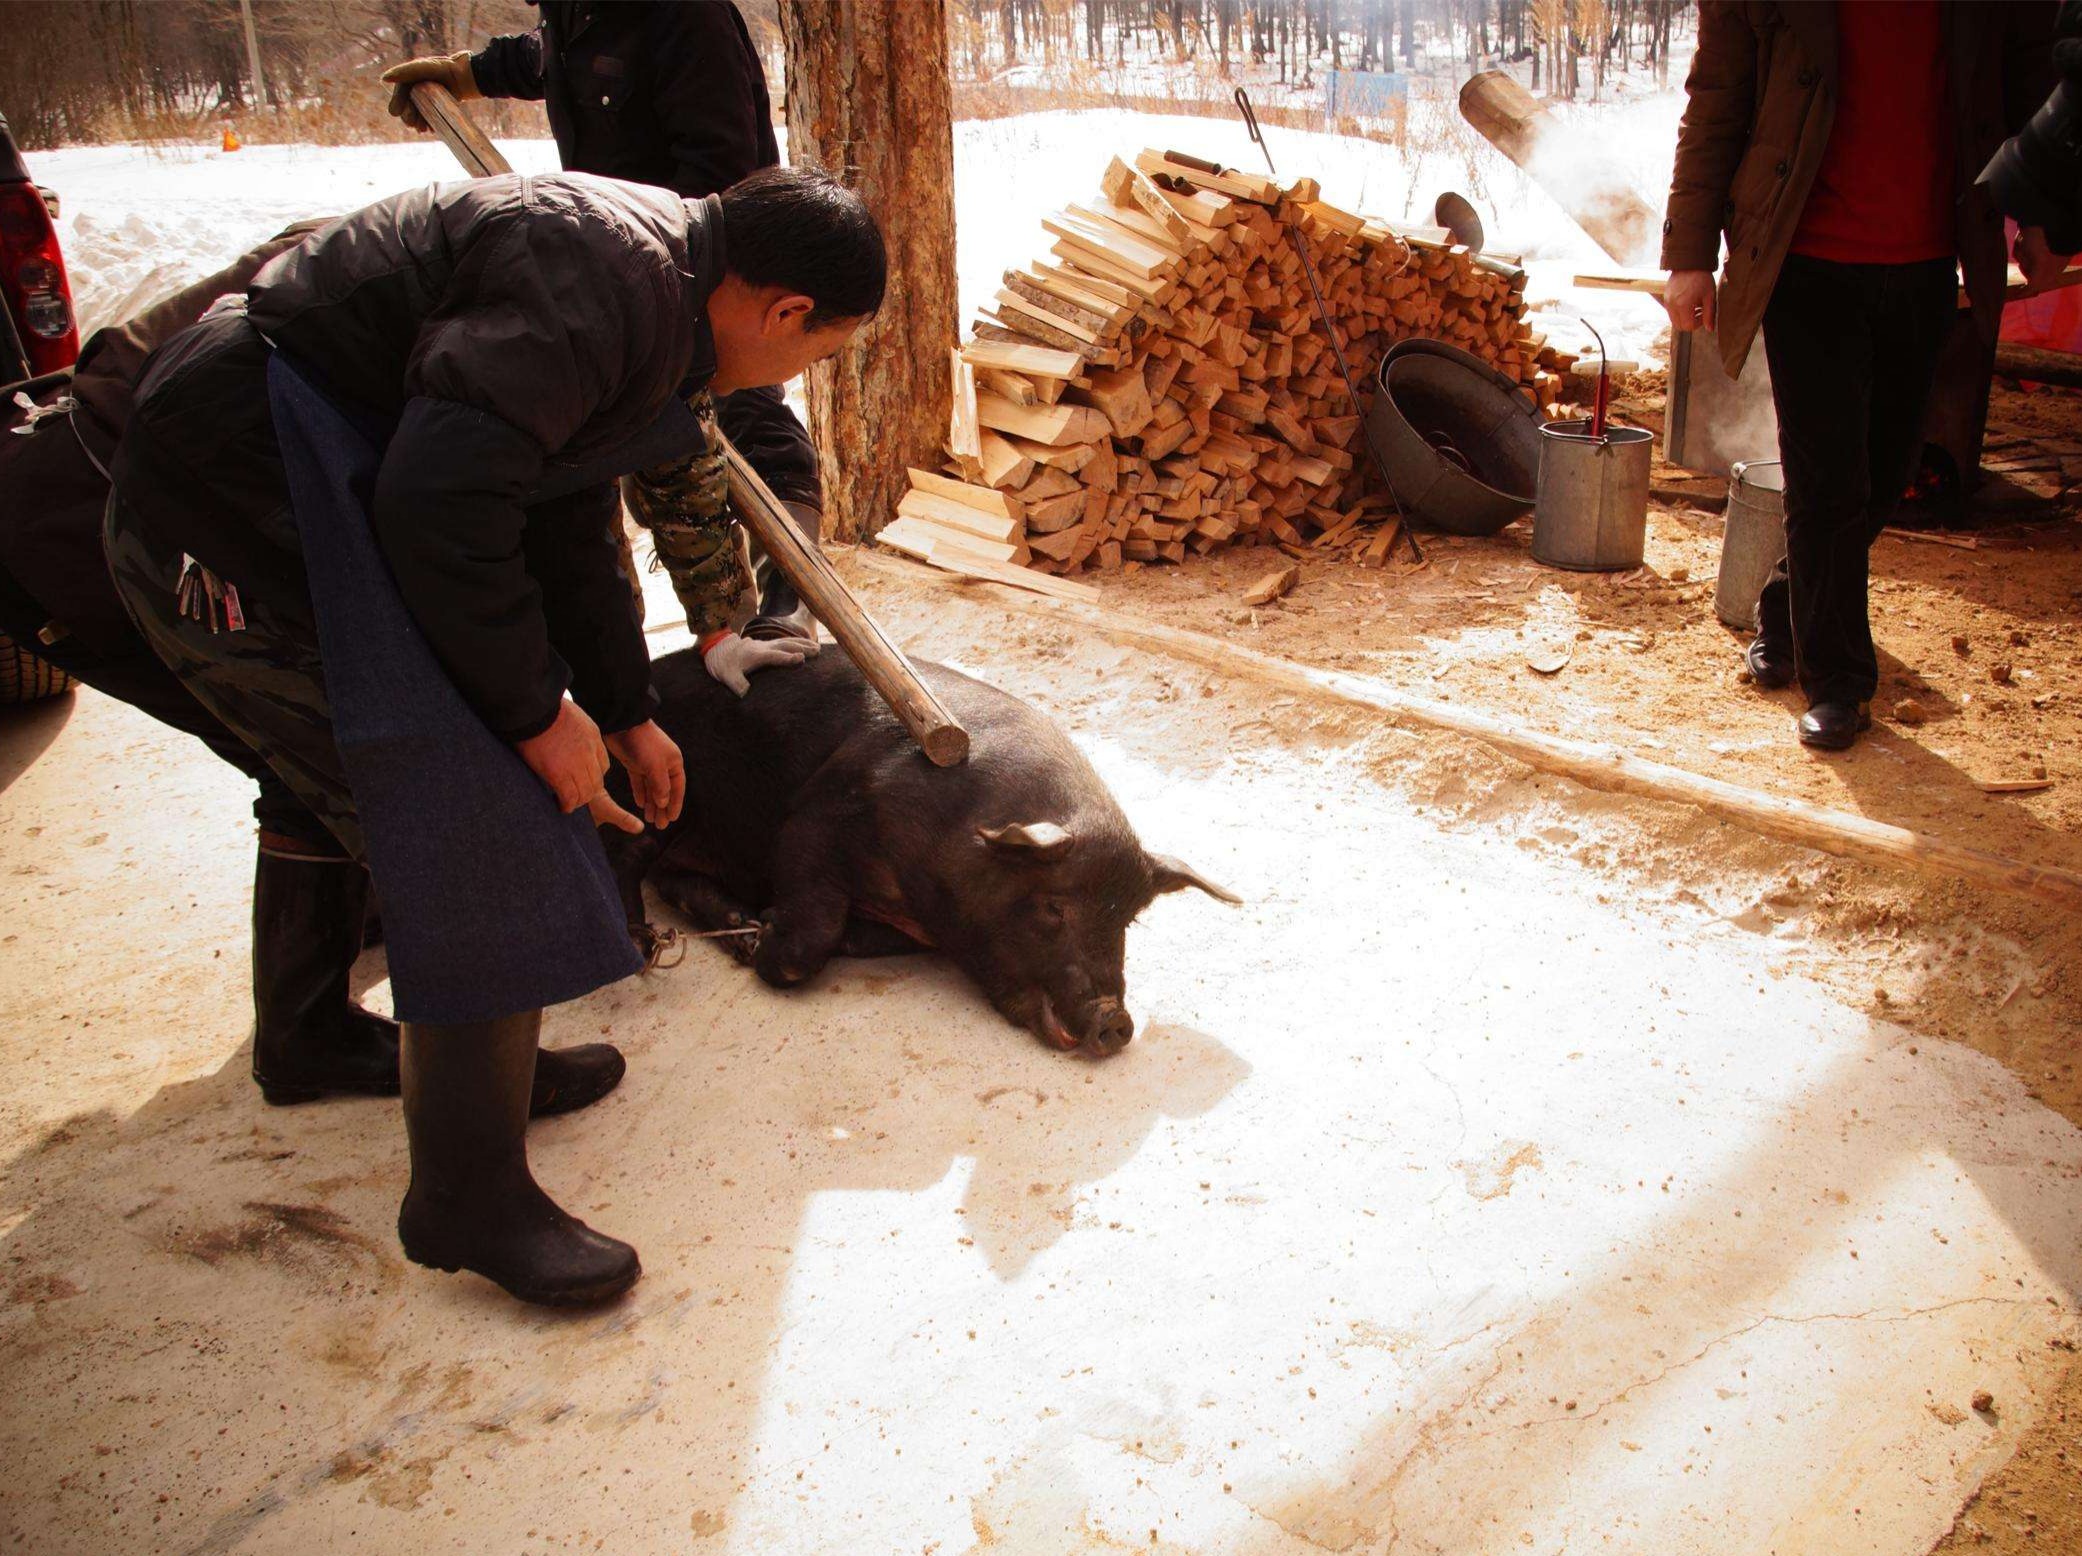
[412,81,968,767]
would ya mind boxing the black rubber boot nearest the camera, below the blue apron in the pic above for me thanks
[398,1010,643,1308]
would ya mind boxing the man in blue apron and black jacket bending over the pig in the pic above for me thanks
[104,169,885,1306]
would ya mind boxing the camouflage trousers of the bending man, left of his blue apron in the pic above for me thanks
[104,492,366,862]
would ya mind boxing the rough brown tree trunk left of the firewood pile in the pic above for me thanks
[781,0,956,539]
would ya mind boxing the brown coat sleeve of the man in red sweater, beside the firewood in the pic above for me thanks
[1661,0,1757,271]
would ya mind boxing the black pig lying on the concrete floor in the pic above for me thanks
[602,648,1239,1054]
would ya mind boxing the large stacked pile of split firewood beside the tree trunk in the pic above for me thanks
[879,150,1570,573]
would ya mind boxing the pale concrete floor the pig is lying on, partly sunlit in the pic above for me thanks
[0,587,2082,1556]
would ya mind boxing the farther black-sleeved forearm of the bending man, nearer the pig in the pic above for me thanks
[521,481,658,735]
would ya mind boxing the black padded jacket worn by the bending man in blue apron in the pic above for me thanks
[115,173,725,739]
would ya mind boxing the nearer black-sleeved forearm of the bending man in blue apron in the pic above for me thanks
[371,396,570,742]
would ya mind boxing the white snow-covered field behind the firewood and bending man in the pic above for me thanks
[29,94,1682,370]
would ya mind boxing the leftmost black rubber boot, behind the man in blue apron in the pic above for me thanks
[254,842,398,1106]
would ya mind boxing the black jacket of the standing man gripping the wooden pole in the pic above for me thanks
[471,0,824,508]
